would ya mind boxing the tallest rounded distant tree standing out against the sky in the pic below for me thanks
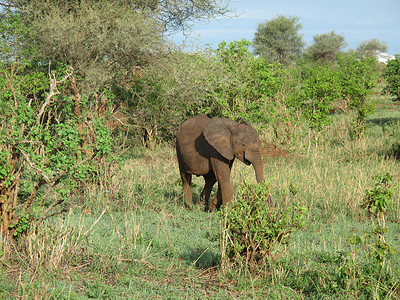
[253,16,305,64]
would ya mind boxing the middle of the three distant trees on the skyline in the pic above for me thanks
[306,31,346,62]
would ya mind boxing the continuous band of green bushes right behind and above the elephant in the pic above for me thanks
[132,40,379,146]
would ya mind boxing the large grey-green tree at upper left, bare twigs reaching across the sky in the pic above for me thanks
[3,0,229,95]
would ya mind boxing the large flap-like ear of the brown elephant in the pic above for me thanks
[203,119,234,160]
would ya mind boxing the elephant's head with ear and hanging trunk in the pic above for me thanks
[203,118,264,183]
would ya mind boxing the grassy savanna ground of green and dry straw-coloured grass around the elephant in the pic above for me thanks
[0,95,400,299]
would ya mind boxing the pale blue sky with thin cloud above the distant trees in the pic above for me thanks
[171,0,400,54]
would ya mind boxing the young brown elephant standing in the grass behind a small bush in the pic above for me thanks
[176,114,264,211]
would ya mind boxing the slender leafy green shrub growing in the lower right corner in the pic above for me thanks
[338,173,398,299]
